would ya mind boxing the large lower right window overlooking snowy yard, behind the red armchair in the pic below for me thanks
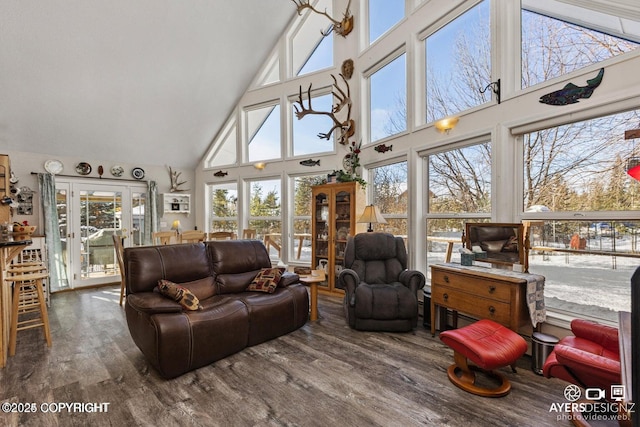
[522,110,640,321]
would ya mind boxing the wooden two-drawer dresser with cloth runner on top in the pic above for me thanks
[431,264,531,335]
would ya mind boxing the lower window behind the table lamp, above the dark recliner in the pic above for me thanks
[368,162,409,237]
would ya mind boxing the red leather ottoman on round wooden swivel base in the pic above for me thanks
[440,319,527,397]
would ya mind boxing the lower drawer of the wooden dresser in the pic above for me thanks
[431,286,511,326]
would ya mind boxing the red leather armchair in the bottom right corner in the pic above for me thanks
[542,319,621,390]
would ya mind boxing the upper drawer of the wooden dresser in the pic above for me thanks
[431,269,511,302]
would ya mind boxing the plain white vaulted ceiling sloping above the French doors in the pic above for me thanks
[0,0,295,167]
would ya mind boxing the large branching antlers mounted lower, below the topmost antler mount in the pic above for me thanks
[293,74,356,145]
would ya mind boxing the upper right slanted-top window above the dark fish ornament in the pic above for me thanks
[522,1,640,88]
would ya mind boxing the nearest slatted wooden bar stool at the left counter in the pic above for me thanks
[5,263,51,356]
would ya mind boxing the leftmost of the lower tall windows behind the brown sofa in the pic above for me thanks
[207,182,238,235]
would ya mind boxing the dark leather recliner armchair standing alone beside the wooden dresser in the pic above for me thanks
[338,232,425,332]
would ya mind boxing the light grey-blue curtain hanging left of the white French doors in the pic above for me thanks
[38,173,69,292]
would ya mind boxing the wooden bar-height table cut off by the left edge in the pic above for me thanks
[0,234,32,368]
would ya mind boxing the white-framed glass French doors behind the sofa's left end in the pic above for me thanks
[52,178,147,291]
